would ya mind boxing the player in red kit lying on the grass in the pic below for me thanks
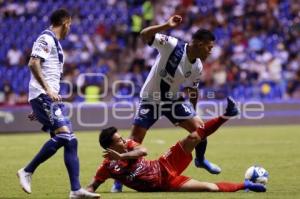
[87,127,266,192]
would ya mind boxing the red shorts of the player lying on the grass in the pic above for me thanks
[158,142,193,191]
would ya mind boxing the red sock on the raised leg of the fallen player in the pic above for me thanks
[197,117,228,139]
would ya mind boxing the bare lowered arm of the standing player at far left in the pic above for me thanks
[28,57,60,101]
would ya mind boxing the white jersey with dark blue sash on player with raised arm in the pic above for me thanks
[140,33,203,103]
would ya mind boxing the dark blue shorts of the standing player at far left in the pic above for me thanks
[30,94,72,134]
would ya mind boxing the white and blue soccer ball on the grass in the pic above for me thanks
[245,166,269,185]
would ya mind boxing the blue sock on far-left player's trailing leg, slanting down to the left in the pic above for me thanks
[24,136,63,173]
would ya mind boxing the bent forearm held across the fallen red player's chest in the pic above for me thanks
[103,146,147,160]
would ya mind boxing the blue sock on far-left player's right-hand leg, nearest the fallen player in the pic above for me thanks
[64,138,81,191]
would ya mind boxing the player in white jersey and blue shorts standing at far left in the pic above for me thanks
[17,9,100,199]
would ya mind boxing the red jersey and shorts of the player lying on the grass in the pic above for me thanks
[94,140,191,191]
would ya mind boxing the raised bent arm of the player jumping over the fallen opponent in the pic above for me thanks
[140,15,182,44]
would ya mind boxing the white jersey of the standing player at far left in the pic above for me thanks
[28,30,63,101]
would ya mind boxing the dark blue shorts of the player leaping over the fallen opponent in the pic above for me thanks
[133,98,196,129]
